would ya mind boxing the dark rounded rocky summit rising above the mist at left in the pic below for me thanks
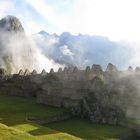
[0,15,24,32]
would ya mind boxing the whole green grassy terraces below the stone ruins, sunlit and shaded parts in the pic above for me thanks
[0,95,136,140]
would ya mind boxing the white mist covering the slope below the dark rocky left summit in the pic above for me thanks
[0,17,63,73]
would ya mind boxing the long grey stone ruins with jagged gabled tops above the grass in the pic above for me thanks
[0,63,140,129]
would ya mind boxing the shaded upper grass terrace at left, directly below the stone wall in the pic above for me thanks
[0,95,67,125]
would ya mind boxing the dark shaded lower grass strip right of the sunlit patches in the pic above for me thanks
[46,118,129,140]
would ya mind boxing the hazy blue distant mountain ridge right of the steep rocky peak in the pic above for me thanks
[34,31,134,68]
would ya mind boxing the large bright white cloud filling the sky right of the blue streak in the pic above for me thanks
[18,0,140,41]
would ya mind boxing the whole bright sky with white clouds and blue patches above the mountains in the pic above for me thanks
[0,0,140,42]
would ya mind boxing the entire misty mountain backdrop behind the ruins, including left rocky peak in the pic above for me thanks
[0,16,136,73]
